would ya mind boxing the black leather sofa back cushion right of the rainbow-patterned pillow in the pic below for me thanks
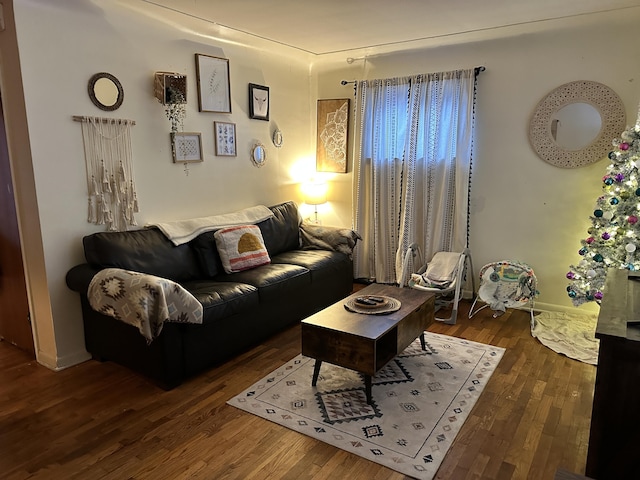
[258,202,300,257]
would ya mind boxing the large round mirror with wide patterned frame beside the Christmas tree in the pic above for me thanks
[529,80,626,168]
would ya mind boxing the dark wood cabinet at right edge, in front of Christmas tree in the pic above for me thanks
[586,269,640,480]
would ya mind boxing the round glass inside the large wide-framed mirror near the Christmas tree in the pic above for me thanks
[551,102,602,150]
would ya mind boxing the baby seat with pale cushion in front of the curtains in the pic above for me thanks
[400,243,475,325]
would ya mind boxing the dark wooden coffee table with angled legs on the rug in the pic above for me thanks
[302,284,435,404]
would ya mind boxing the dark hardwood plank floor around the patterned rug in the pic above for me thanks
[0,294,596,480]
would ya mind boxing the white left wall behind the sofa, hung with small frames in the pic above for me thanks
[15,0,313,368]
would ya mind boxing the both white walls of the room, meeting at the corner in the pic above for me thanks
[9,0,640,368]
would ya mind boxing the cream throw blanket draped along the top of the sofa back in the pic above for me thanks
[149,205,273,245]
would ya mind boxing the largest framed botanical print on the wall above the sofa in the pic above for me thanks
[196,53,231,113]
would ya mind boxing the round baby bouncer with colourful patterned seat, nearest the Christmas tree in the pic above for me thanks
[469,260,538,324]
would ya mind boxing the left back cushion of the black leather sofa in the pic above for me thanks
[82,227,202,282]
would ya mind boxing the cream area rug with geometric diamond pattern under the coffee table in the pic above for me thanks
[227,332,504,480]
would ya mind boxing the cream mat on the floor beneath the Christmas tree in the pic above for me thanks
[531,312,600,365]
